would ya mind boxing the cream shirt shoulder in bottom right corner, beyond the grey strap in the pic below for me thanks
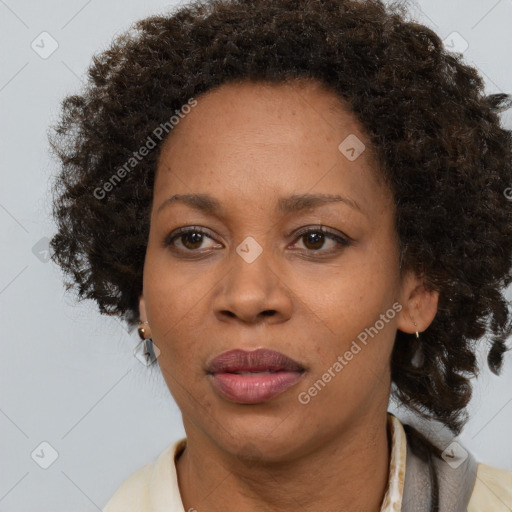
[468,463,512,512]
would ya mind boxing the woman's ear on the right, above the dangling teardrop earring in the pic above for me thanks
[397,272,439,334]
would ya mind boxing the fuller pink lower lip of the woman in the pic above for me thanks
[211,371,302,404]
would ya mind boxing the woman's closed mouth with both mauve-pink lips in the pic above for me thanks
[207,349,305,404]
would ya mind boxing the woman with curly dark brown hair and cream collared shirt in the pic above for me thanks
[52,0,512,512]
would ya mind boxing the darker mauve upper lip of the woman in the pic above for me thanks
[207,348,304,373]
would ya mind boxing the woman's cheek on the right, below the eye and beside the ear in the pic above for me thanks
[292,237,400,388]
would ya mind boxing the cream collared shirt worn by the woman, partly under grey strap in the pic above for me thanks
[103,413,512,512]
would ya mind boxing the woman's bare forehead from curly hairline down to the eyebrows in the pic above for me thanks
[155,81,388,215]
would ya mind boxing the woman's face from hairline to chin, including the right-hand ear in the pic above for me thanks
[140,79,435,459]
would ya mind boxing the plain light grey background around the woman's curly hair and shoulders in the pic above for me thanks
[0,0,512,512]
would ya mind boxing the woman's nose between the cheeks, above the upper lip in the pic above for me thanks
[214,245,293,323]
